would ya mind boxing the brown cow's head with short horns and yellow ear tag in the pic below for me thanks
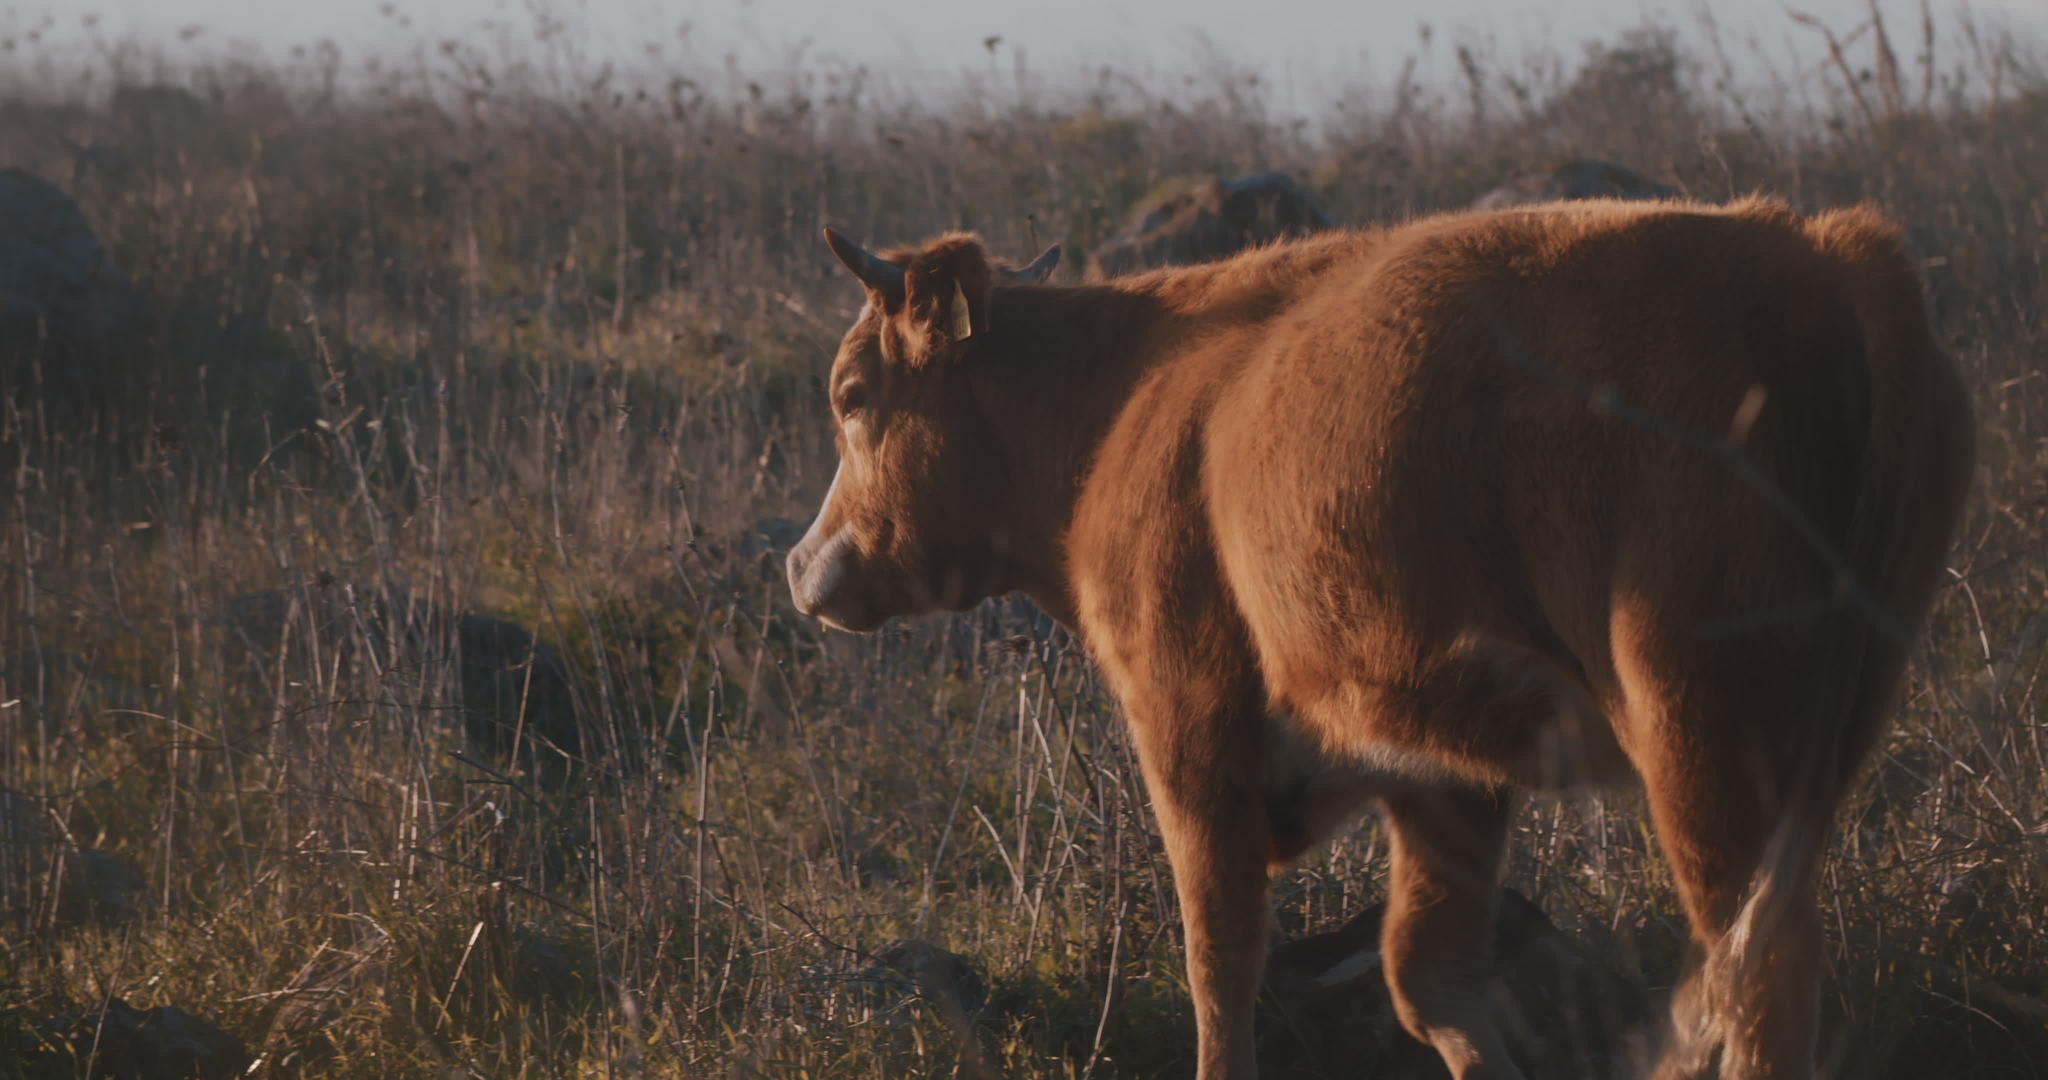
[788,230,1059,631]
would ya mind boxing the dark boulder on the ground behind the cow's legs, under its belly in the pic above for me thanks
[1260,889,1647,1080]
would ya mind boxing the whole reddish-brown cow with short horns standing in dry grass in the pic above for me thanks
[788,201,1972,1080]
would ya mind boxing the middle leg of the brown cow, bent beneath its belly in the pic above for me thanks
[1380,787,1522,1080]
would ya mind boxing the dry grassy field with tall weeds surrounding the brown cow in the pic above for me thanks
[0,10,2048,1078]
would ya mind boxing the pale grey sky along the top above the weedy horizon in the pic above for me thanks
[0,0,2048,113]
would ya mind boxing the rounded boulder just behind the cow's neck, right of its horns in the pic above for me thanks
[1087,172,1331,281]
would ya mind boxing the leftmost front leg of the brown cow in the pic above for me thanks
[1124,672,1272,1080]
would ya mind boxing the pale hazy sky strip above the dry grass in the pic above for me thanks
[0,0,2048,96]
